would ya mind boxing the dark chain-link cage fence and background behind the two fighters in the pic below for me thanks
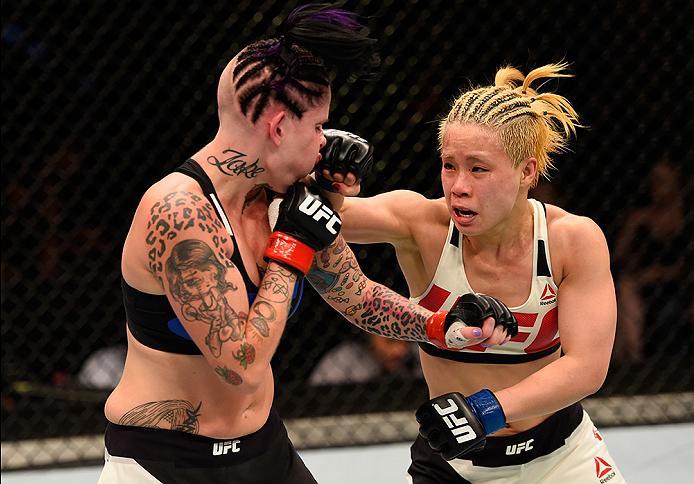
[2,0,694,450]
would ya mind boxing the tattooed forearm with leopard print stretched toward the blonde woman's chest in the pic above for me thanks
[306,237,428,341]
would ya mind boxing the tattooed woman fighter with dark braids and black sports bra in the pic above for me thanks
[99,5,512,484]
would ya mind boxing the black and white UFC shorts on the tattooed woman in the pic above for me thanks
[100,409,316,484]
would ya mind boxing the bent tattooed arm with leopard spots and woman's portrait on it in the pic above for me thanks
[136,189,297,392]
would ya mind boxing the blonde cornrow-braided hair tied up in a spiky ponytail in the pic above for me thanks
[439,63,581,184]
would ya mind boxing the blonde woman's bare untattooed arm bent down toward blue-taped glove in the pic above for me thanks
[494,216,617,422]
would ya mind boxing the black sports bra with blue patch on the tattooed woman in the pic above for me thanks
[121,159,304,355]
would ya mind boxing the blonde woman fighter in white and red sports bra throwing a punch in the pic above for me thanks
[319,63,624,484]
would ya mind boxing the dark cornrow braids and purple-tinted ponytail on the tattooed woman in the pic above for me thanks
[232,4,380,123]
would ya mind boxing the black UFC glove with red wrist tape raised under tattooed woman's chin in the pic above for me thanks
[264,182,342,275]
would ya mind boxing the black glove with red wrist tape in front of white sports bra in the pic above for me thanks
[427,292,518,349]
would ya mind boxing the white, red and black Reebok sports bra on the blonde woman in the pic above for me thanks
[410,199,560,364]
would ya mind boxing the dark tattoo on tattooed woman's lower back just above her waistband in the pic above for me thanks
[118,400,202,434]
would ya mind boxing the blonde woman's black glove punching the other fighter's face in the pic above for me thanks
[316,129,373,192]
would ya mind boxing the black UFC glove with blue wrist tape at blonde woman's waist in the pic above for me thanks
[415,389,506,460]
